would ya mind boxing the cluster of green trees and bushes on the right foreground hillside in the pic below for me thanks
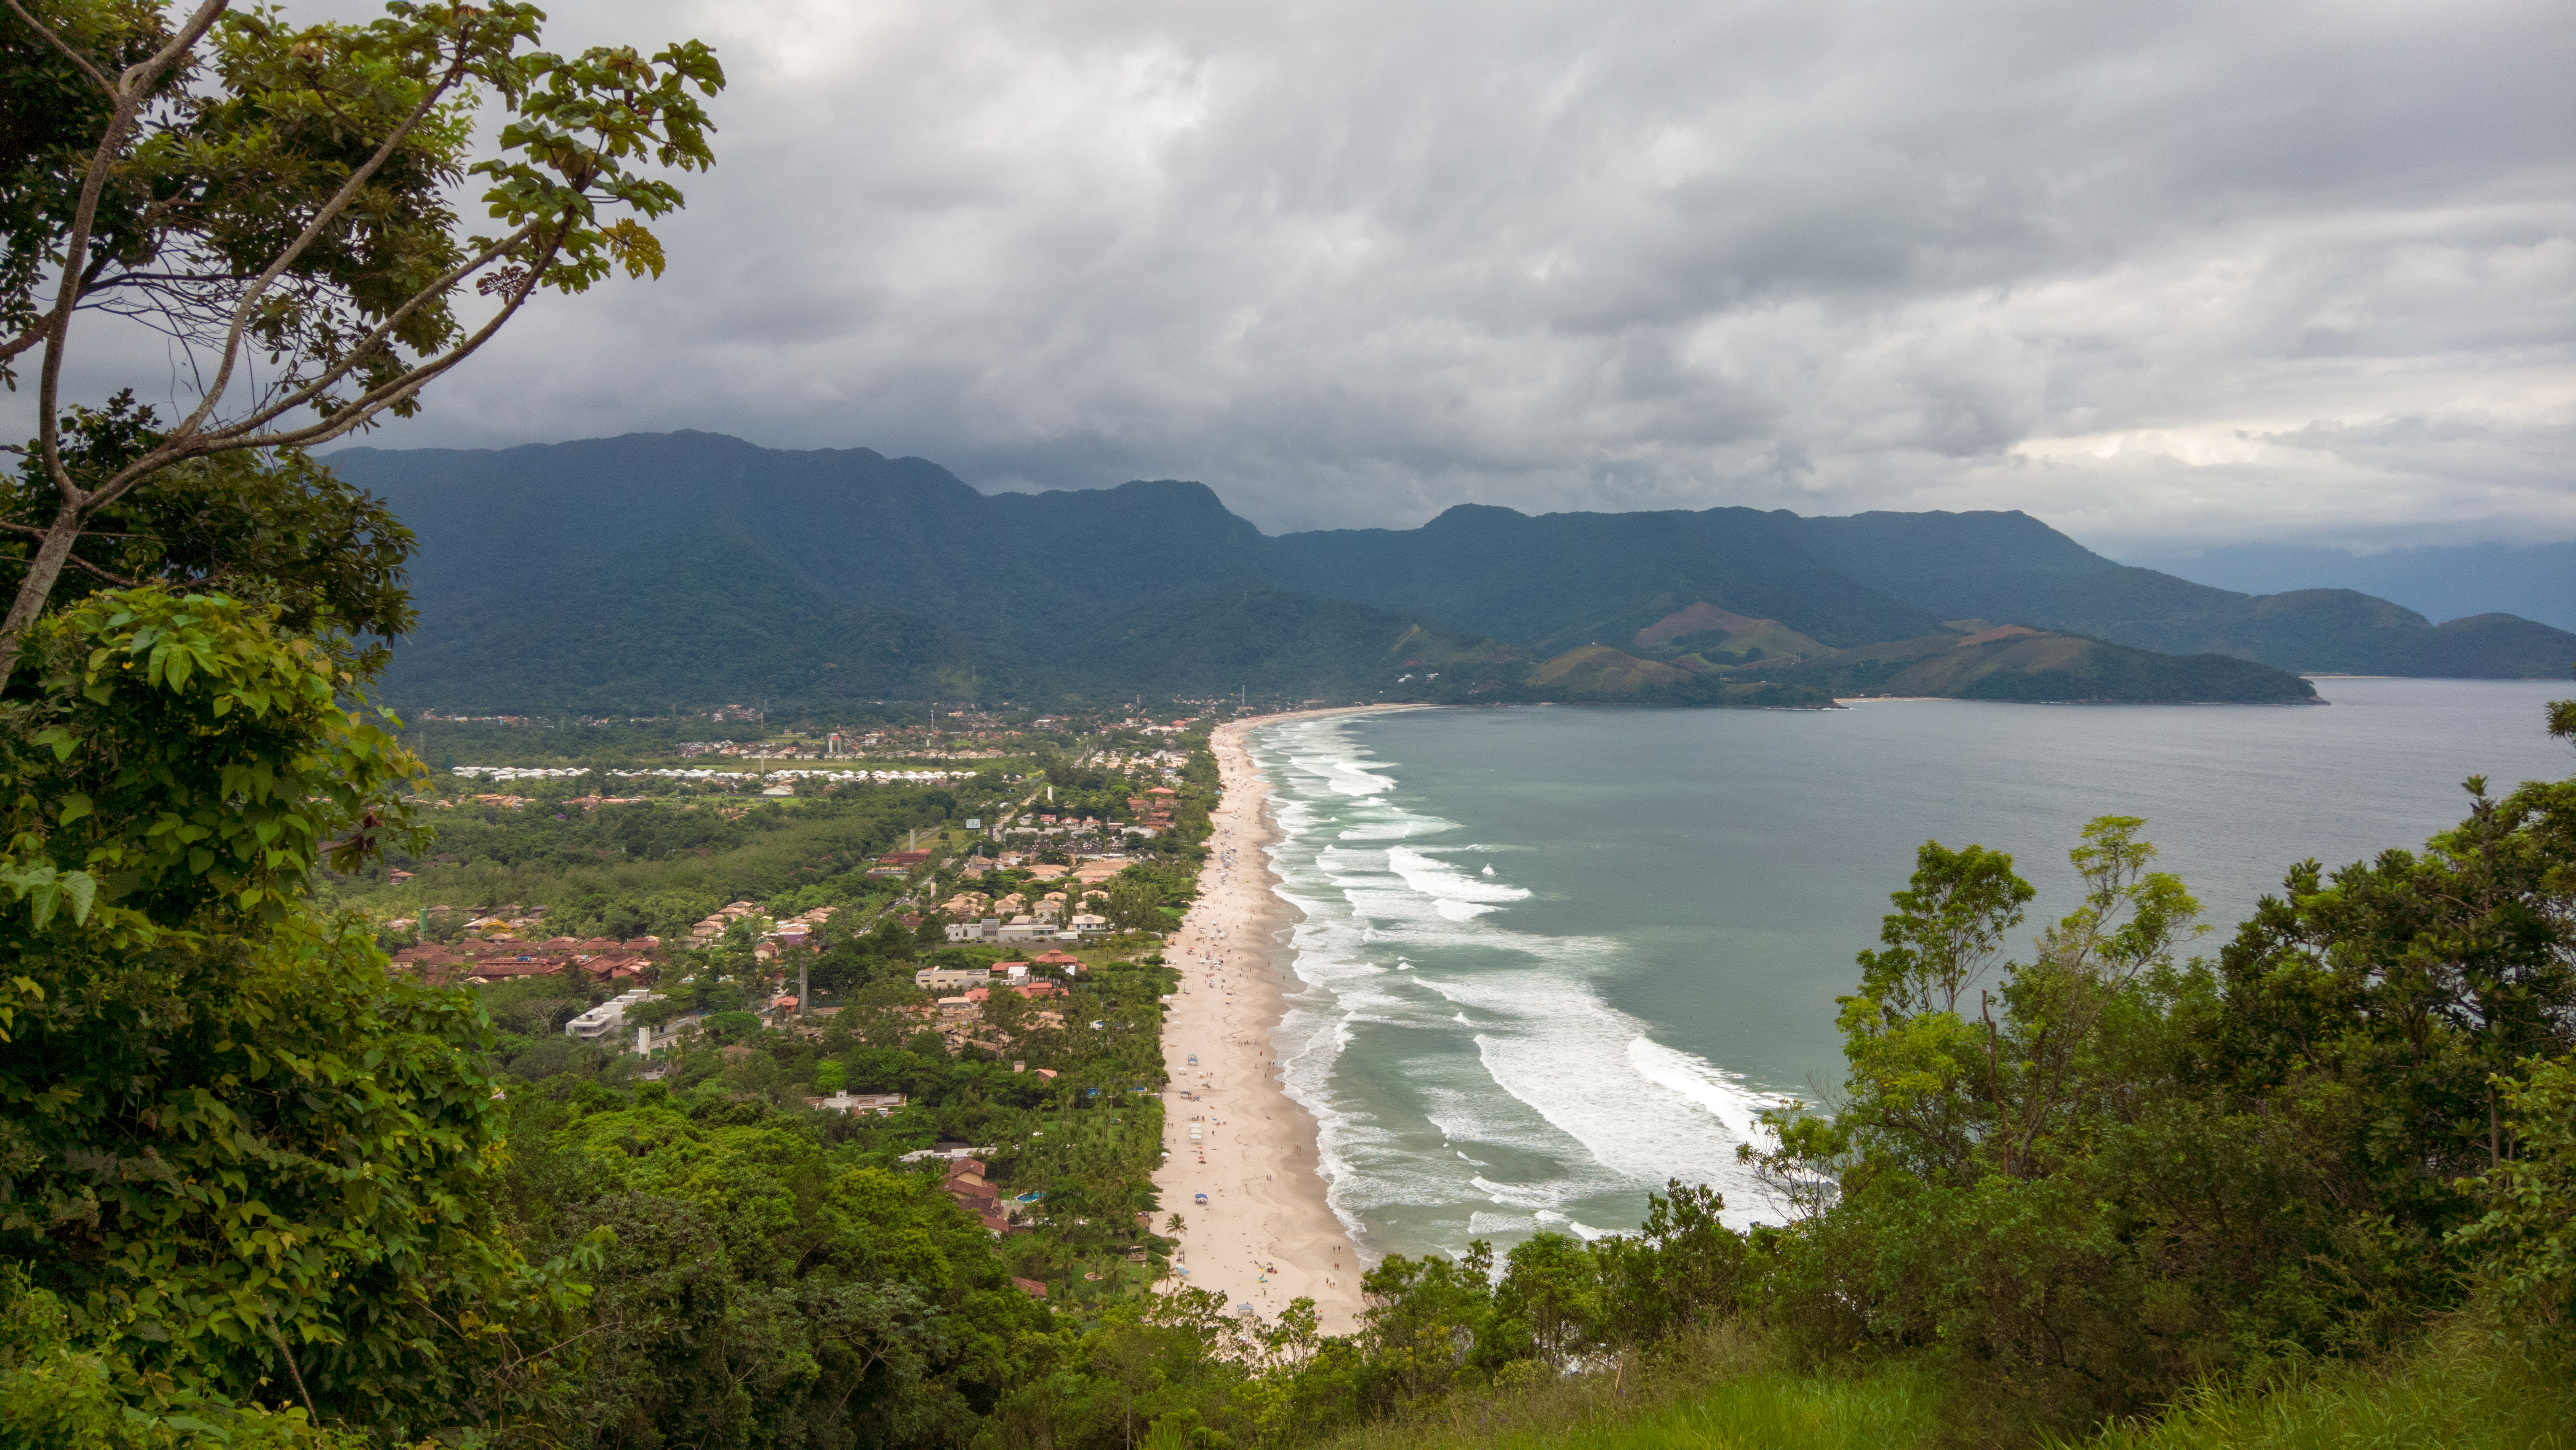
[1749,757,2576,1432]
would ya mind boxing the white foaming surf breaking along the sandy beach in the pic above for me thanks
[1252,721,1765,1252]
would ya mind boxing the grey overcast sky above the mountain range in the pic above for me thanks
[60,0,2576,554]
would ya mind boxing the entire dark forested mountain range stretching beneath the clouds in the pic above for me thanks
[330,433,2576,713]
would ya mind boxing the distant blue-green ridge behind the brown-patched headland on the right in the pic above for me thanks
[1270,508,2576,677]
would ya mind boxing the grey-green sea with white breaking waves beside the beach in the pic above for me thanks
[1252,680,2576,1254]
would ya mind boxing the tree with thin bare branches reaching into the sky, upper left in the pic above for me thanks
[0,0,724,685]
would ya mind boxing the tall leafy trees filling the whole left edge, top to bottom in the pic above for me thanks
[0,0,724,1445]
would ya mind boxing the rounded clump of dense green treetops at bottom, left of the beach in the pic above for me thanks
[510,1097,1048,1445]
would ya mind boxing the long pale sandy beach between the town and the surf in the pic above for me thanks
[1154,711,1422,1334]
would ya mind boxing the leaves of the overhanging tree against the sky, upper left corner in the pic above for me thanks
[8,0,724,407]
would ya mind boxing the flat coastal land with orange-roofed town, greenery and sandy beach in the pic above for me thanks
[335,706,1363,1329]
